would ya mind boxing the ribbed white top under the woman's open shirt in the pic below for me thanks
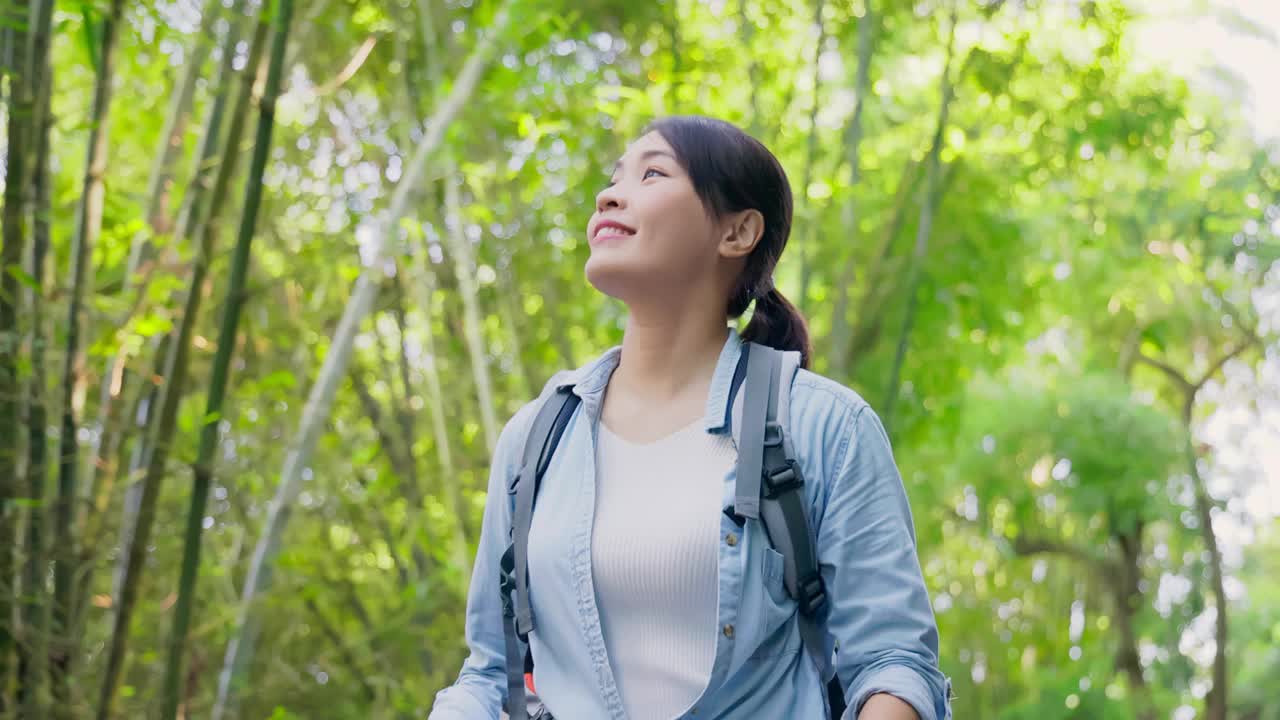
[591,418,737,720]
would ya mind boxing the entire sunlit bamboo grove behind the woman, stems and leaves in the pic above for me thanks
[0,0,1280,720]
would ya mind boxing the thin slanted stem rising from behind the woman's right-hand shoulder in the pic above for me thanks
[882,3,956,432]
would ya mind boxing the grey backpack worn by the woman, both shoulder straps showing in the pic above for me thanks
[500,342,845,720]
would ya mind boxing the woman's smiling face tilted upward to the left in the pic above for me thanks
[585,132,721,305]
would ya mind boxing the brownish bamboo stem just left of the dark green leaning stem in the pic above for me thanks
[97,8,272,720]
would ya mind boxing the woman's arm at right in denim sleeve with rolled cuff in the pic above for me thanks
[818,402,951,720]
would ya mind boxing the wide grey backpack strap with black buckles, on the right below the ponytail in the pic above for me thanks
[733,342,833,682]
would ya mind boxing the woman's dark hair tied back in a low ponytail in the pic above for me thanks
[641,115,813,368]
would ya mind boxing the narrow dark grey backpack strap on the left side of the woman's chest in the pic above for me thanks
[500,386,581,720]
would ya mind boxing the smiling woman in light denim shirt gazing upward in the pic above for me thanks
[430,117,951,720]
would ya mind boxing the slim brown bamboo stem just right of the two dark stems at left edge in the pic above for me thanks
[52,0,124,714]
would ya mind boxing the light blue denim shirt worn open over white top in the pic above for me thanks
[430,327,951,720]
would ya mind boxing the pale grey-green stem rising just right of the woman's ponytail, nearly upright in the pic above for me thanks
[828,0,876,378]
